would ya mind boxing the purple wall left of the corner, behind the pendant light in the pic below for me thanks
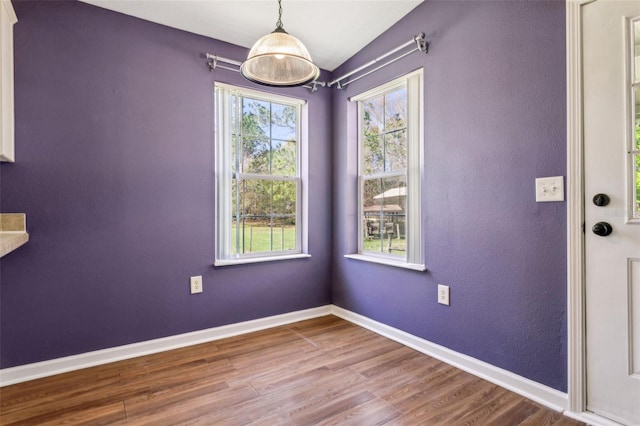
[0,1,331,368]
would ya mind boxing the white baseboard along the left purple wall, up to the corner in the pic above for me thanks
[0,305,331,386]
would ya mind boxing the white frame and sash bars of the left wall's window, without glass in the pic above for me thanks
[214,83,310,266]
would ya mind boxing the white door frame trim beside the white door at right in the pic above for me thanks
[566,0,632,425]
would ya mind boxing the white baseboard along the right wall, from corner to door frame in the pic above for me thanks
[331,305,568,412]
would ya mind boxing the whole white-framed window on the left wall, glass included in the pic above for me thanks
[215,84,308,266]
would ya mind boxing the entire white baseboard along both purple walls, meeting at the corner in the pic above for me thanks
[0,305,568,420]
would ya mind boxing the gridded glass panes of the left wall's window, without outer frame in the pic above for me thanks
[232,97,298,255]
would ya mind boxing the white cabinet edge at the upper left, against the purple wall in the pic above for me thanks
[0,0,18,161]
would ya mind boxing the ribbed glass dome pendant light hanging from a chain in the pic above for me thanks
[240,0,320,87]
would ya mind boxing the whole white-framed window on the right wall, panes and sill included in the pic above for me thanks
[347,70,425,270]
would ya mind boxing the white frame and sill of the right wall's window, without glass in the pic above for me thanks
[345,69,426,271]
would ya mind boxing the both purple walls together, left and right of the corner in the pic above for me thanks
[0,1,567,391]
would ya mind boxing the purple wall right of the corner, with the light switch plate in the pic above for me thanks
[332,1,567,391]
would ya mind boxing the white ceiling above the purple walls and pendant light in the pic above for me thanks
[83,0,423,71]
